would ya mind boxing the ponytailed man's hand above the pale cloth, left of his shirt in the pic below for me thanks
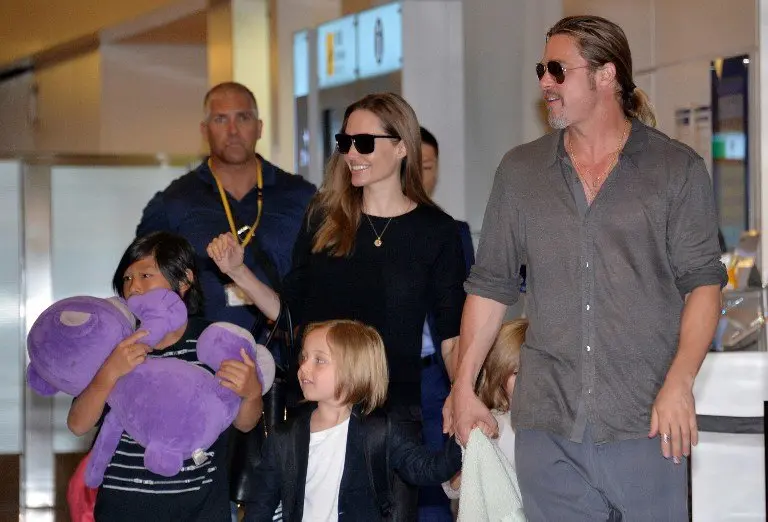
[443,385,499,446]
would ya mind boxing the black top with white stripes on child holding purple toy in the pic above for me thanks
[95,317,230,522]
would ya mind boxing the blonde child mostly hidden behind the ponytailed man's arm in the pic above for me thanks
[443,319,528,499]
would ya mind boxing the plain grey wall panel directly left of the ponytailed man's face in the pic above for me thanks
[463,0,562,234]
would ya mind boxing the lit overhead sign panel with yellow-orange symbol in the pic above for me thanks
[317,15,357,89]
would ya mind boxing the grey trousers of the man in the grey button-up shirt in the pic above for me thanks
[515,426,689,522]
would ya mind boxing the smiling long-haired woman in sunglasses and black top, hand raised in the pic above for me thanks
[208,93,465,520]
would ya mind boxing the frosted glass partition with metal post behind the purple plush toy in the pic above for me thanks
[0,157,193,522]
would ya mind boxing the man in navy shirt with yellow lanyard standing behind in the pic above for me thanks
[136,82,315,330]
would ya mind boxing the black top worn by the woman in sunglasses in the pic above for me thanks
[282,205,465,406]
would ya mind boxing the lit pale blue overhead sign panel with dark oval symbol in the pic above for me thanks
[357,2,403,78]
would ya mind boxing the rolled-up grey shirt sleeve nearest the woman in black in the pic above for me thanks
[464,154,522,306]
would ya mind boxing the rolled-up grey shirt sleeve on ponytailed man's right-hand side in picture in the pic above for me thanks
[667,157,728,295]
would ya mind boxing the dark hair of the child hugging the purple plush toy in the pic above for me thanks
[112,232,203,315]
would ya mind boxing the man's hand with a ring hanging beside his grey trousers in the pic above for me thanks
[648,377,699,464]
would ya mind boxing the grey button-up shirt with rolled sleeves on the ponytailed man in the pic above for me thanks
[465,120,727,442]
